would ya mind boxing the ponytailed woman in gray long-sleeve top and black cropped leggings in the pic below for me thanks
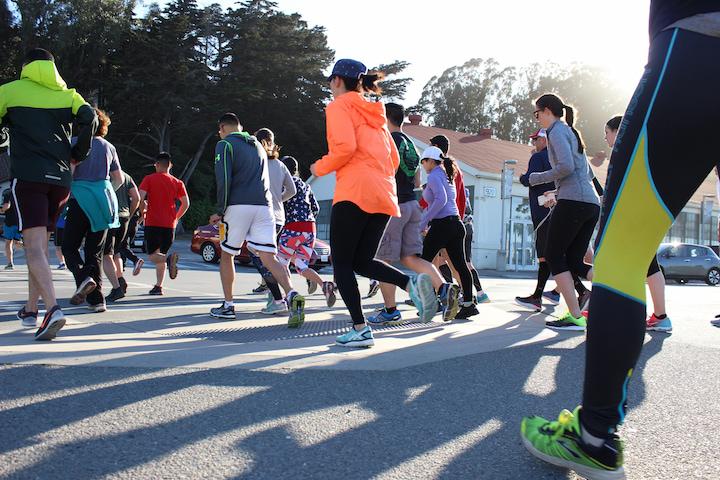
[528,94,600,330]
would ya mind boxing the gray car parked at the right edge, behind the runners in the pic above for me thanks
[658,243,720,286]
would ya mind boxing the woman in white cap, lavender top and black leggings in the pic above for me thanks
[420,147,480,318]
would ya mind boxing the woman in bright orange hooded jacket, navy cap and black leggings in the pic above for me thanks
[310,59,437,347]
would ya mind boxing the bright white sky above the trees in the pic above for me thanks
[149,0,650,106]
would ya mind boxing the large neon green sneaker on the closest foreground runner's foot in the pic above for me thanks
[520,407,625,480]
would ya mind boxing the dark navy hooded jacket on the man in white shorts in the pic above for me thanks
[215,132,272,214]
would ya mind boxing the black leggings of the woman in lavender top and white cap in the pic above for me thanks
[422,215,473,302]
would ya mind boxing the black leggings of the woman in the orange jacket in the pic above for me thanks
[330,202,410,325]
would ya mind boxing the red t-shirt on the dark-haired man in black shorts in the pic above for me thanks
[140,173,187,228]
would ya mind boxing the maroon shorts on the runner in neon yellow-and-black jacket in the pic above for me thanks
[12,180,70,231]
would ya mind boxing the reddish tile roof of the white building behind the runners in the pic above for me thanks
[403,123,716,204]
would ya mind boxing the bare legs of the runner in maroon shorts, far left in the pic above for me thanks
[23,227,57,312]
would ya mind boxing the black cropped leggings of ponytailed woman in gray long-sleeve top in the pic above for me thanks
[545,200,600,278]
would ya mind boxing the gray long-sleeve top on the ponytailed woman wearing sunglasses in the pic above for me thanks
[529,120,600,205]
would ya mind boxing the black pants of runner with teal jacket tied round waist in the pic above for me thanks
[62,198,107,305]
